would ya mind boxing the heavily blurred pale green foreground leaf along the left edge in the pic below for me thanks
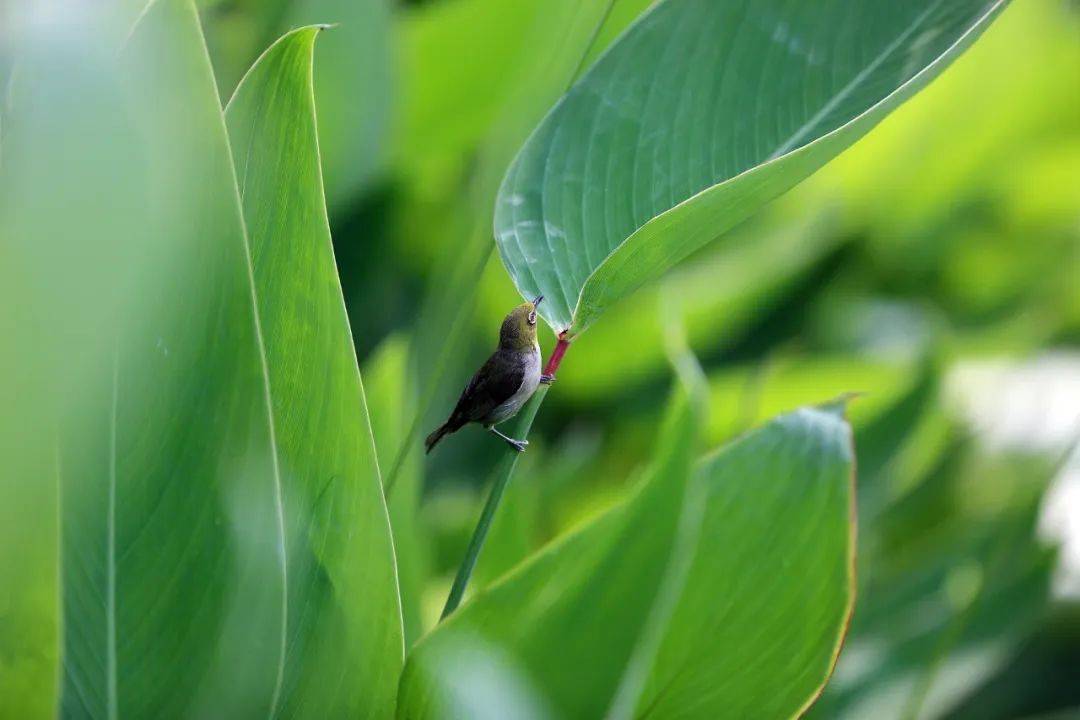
[0,6,156,719]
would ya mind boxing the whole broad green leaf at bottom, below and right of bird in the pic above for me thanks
[399,398,853,718]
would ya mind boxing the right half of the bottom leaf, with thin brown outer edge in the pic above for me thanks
[636,406,855,718]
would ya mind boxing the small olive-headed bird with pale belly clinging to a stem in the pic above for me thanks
[423,295,553,452]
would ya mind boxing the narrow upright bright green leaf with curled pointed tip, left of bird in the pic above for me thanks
[226,27,403,717]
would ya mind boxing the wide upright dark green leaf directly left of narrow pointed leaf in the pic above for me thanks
[56,0,287,718]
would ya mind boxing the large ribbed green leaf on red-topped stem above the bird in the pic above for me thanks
[495,0,1005,334]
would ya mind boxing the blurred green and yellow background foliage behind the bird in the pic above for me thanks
[0,0,1080,718]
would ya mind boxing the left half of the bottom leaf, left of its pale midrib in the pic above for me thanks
[397,379,697,718]
